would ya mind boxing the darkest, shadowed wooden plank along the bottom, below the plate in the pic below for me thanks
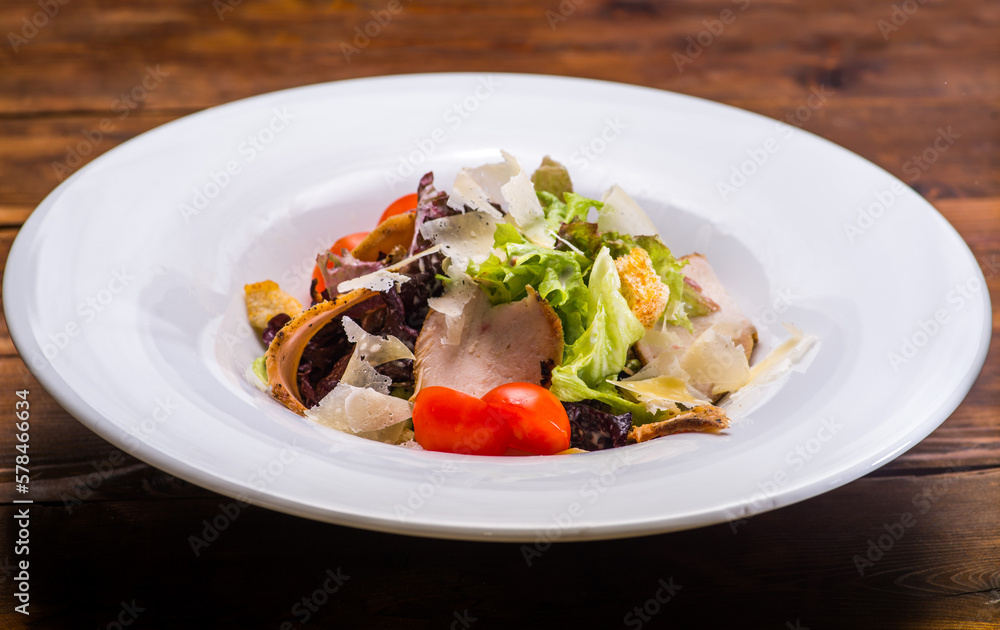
[0,471,1000,630]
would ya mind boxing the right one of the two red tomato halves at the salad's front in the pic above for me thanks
[483,383,570,455]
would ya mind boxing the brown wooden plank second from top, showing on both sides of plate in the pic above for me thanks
[0,101,1000,214]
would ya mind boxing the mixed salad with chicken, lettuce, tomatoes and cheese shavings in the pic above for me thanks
[245,152,803,455]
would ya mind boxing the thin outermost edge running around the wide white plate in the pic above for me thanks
[3,72,992,542]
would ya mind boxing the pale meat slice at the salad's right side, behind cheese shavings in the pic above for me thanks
[636,254,757,363]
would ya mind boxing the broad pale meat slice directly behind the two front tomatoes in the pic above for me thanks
[413,287,563,396]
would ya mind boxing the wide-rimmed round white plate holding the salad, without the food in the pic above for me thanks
[3,74,990,541]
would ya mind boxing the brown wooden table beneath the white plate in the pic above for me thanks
[0,0,1000,629]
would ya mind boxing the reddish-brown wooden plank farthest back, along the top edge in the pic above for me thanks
[0,0,1000,114]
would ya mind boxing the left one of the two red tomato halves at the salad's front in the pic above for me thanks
[413,387,511,455]
